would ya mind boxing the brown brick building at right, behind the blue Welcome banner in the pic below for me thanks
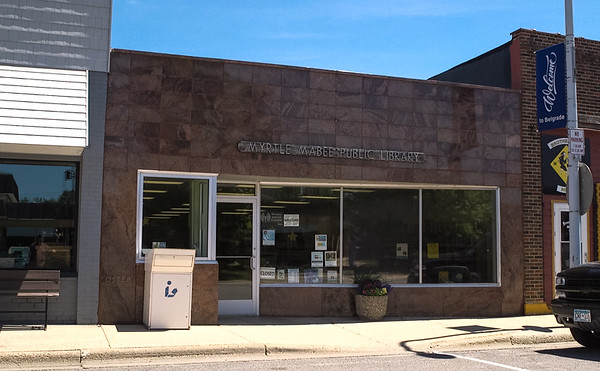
[432,29,600,313]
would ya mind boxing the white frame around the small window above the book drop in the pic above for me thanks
[135,170,217,264]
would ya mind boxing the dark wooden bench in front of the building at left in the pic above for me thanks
[0,269,60,330]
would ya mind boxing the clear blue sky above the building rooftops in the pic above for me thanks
[111,0,600,79]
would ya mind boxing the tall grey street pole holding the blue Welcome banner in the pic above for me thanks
[565,0,582,267]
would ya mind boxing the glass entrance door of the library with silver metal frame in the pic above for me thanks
[217,197,258,315]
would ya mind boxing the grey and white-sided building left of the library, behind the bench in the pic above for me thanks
[0,0,112,324]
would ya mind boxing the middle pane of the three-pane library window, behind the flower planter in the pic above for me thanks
[343,188,419,284]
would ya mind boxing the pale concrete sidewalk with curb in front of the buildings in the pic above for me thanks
[0,315,573,367]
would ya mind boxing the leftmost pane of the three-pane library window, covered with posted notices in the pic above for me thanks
[261,186,340,284]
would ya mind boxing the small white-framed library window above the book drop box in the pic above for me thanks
[137,172,216,259]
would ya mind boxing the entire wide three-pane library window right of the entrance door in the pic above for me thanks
[260,185,498,284]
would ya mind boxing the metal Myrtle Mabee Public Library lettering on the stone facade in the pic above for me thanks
[238,141,425,162]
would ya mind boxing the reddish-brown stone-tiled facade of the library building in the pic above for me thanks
[99,50,525,324]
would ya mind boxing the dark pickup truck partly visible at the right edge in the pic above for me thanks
[551,262,600,348]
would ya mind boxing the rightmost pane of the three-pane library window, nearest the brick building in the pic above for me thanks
[423,190,497,283]
